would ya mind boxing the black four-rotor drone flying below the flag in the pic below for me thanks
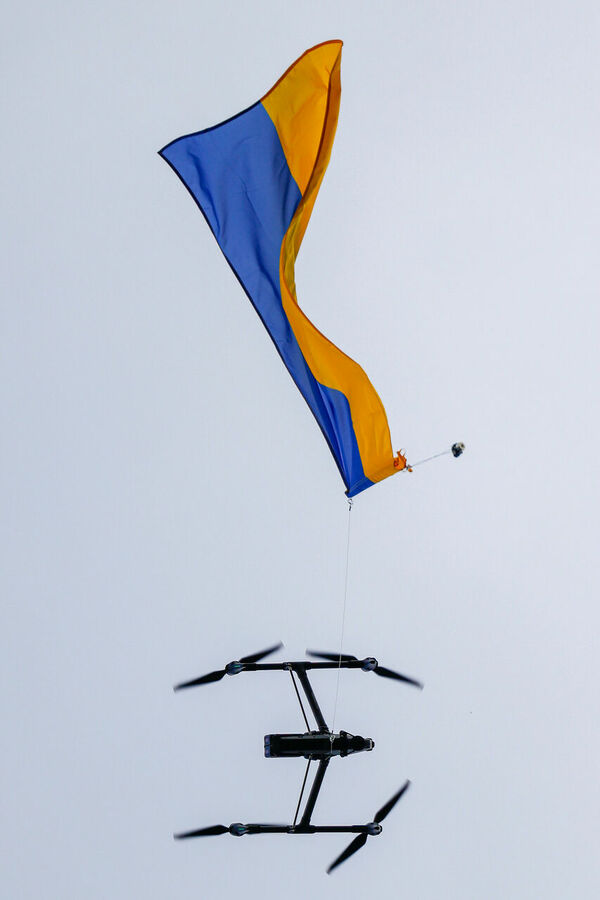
[174,643,423,874]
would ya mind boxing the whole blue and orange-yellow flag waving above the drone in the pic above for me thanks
[160,41,406,497]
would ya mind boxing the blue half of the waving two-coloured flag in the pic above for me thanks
[160,103,372,493]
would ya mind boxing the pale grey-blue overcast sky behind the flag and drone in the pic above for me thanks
[0,0,600,900]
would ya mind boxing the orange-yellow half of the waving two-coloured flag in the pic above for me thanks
[263,41,404,481]
